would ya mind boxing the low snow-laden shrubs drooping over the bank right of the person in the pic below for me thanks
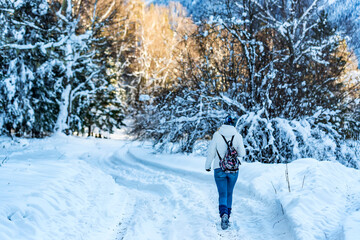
[237,112,360,168]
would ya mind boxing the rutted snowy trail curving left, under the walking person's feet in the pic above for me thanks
[98,147,293,240]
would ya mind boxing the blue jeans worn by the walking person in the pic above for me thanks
[214,168,239,217]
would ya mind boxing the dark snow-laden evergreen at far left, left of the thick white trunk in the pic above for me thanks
[0,0,60,137]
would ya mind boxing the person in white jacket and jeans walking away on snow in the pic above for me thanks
[205,116,245,230]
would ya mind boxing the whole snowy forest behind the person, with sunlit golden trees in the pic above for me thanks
[0,0,360,168]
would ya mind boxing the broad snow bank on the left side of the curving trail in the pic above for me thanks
[0,138,127,240]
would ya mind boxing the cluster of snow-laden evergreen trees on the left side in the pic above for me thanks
[0,0,124,137]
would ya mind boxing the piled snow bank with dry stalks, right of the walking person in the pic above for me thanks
[236,159,360,240]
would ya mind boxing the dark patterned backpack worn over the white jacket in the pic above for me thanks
[216,135,241,172]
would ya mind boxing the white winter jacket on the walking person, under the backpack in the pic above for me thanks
[205,125,245,169]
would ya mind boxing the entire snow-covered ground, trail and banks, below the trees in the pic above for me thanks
[0,136,360,240]
